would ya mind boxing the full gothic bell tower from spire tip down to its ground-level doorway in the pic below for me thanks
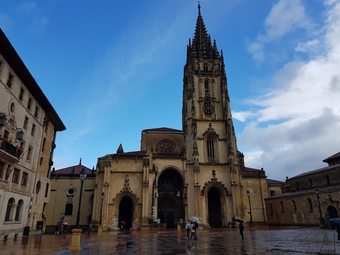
[182,5,241,223]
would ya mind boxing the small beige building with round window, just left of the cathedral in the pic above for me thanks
[46,162,96,232]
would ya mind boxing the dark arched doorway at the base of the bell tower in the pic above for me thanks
[208,187,222,228]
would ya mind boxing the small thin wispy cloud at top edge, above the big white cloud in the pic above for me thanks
[248,0,311,62]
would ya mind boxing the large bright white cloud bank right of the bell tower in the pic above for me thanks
[239,2,340,179]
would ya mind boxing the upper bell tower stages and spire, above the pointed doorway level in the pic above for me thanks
[182,5,237,167]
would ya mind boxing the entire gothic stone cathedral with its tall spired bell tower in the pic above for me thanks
[92,6,280,230]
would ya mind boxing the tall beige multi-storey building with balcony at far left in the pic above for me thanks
[0,29,65,240]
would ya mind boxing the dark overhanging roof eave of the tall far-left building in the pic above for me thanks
[0,28,66,131]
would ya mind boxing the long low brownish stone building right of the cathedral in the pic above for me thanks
[265,153,340,225]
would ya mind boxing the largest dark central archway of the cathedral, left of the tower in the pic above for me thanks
[158,169,184,228]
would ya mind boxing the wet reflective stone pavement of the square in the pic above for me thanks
[0,228,340,255]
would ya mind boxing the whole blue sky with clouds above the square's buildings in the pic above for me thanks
[0,0,340,180]
